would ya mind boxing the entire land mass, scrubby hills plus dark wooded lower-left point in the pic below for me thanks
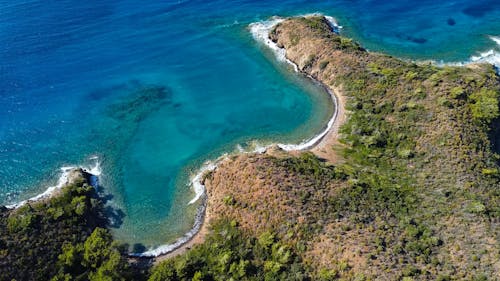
[0,15,500,281]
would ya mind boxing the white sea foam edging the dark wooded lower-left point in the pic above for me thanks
[5,156,101,209]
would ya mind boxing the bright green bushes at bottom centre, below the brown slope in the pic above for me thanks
[149,220,307,281]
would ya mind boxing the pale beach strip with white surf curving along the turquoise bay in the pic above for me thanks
[142,14,347,262]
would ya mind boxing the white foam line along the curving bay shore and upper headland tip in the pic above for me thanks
[130,13,342,257]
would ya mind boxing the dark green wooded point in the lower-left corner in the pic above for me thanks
[0,168,132,281]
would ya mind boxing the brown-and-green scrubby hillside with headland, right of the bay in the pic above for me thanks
[153,17,500,280]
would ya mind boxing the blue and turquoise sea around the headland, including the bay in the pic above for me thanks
[0,0,500,247]
